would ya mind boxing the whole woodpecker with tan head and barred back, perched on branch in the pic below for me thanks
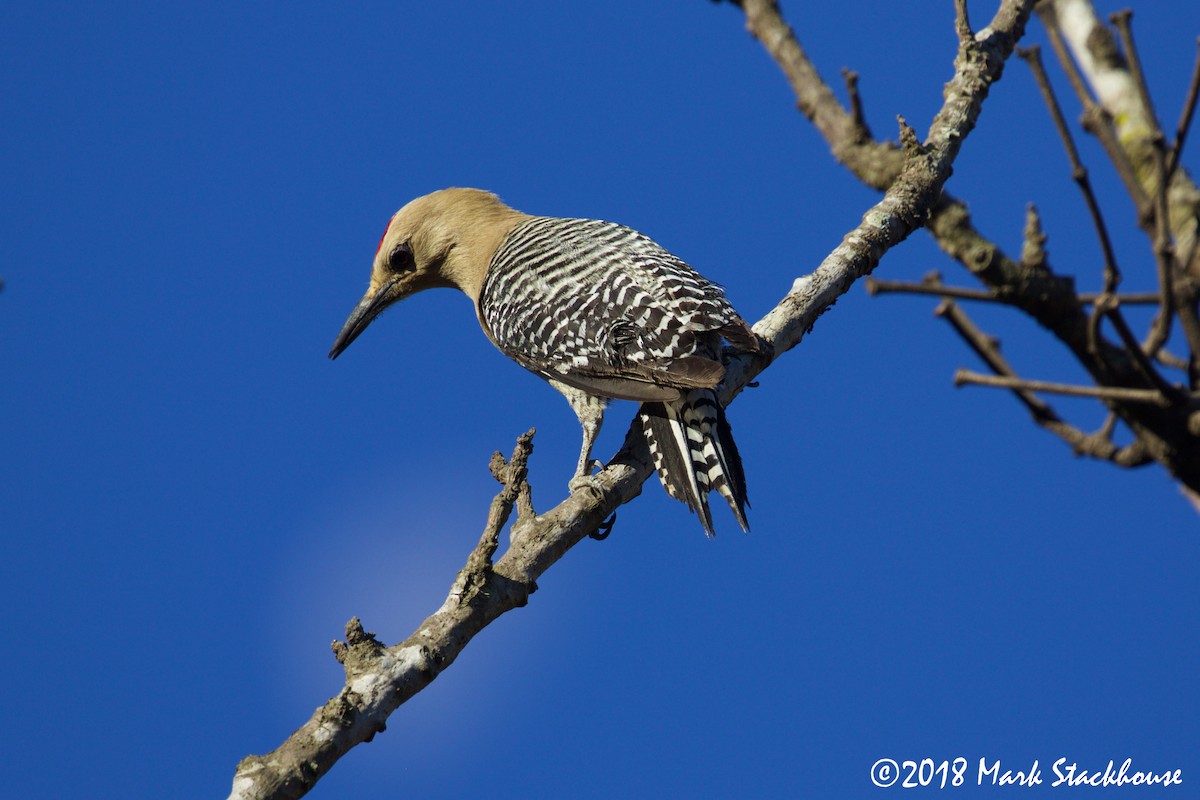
[329,188,758,536]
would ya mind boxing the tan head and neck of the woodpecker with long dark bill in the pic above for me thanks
[329,188,526,359]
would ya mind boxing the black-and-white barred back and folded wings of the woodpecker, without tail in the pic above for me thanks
[479,217,755,401]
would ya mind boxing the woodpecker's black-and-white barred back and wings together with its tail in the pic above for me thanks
[479,217,757,535]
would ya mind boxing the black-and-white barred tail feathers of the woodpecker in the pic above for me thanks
[638,389,750,536]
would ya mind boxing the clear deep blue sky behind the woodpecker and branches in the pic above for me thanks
[0,0,1200,798]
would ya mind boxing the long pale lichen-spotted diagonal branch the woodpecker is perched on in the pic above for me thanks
[230,0,1033,798]
